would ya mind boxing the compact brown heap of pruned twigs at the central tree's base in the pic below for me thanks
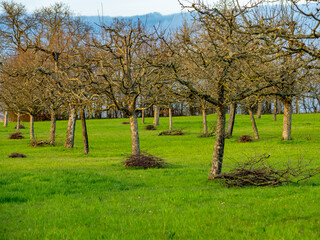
[123,153,166,168]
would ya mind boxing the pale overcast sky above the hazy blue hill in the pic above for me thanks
[15,0,185,16]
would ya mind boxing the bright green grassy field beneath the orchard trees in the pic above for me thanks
[0,114,320,239]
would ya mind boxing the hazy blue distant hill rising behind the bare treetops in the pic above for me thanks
[81,12,191,29]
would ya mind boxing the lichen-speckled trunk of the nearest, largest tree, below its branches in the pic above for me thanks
[209,105,226,180]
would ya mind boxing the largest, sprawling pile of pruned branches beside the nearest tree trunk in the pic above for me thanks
[215,154,320,187]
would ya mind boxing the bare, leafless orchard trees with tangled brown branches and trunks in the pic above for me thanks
[0,0,320,179]
